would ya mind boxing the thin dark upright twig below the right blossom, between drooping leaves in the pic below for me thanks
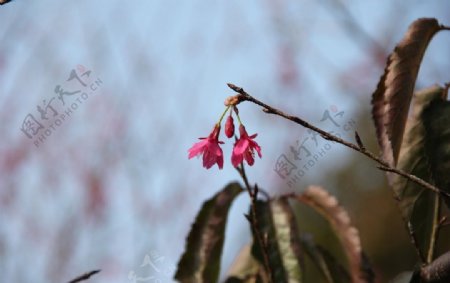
[236,163,272,283]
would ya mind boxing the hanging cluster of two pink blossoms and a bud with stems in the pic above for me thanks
[188,97,262,169]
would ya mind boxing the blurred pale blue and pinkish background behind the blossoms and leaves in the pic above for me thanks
[0,0,450,283]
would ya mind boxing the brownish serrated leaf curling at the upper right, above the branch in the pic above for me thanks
[372,18,443,173]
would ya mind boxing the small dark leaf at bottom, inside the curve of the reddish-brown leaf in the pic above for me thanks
[301,235,350,283]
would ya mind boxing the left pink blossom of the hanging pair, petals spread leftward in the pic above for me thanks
[188,125,223,169]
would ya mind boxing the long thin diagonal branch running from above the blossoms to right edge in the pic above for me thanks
[228,83,450,200]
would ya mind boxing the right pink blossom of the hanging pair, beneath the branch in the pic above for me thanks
[231,124,262,167]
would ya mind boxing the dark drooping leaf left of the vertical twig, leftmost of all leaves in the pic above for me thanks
[175,183,243,283]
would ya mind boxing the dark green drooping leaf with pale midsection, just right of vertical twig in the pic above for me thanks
[250,197,303,283]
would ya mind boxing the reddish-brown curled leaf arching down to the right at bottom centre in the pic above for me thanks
[297,186,373,283]
